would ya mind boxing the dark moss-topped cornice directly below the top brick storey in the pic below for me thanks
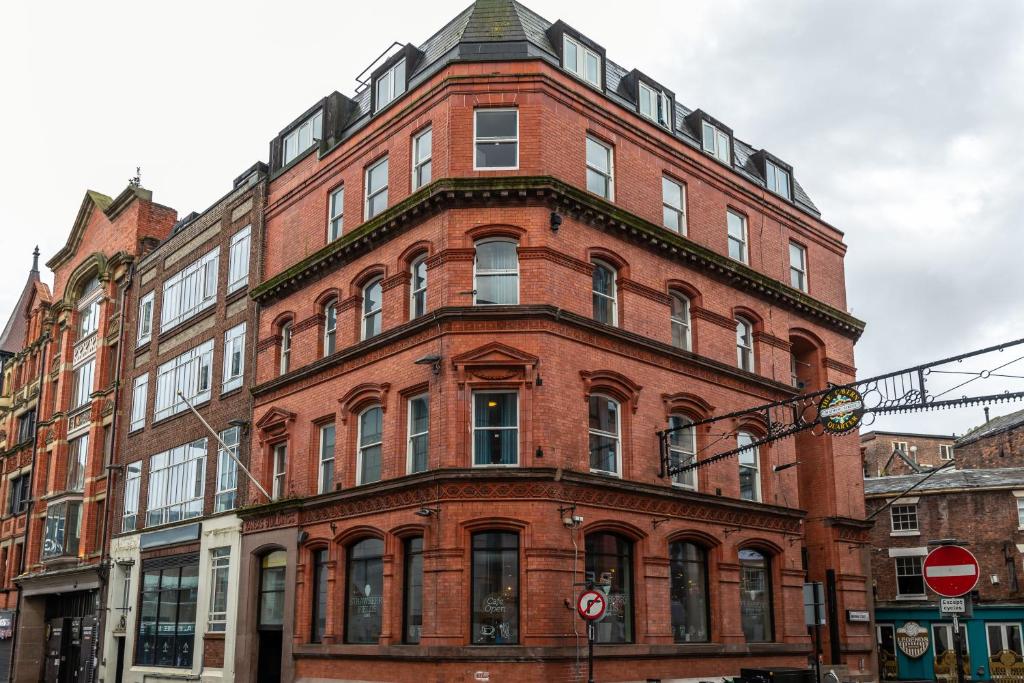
[251,176,864,339]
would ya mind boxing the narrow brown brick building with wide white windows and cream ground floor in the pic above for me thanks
[99,164,266,683]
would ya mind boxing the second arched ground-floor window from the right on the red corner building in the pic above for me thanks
[669,542,709,643]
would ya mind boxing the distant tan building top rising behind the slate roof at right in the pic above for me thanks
[860,431,959,477]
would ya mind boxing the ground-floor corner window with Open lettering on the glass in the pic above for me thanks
[471,531,519,645]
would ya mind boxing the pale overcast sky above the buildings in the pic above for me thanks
[0,0,1024,433]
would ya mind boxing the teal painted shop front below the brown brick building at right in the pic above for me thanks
[874,603,1024,683]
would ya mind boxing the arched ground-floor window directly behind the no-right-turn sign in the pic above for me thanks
[586,532,633,643]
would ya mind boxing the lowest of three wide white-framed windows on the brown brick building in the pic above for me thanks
[145,437,207,527]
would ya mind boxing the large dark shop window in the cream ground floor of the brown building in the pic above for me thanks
[135,557,199,668]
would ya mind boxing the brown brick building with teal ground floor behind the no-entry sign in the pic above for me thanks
[865,411,1024,681]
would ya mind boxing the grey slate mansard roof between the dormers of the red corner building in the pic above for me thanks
[283,0,821,217]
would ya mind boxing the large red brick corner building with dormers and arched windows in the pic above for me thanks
[236,0,873,682]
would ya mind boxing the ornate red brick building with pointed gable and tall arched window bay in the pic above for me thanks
[5,184,175,682]
